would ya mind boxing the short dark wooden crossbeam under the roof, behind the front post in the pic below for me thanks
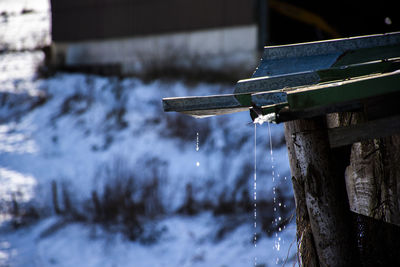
[328,116,400,148]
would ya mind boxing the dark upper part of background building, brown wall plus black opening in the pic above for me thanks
[51,0,400,47]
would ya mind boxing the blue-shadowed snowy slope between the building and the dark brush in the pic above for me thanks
[0,70,290,210]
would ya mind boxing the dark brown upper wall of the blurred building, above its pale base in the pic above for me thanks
[51,0,254,42]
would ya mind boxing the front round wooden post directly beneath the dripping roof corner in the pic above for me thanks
[285,117,356,266]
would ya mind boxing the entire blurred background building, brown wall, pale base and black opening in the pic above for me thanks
[50,0,398,77]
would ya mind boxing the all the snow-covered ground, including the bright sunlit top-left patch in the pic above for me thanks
[0,0,296,266]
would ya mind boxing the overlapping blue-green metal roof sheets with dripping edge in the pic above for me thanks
[163,32,400,122]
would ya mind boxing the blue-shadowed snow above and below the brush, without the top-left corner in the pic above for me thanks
[0,65,294,266]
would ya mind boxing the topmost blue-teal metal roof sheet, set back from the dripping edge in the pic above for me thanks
[253,32,400,78]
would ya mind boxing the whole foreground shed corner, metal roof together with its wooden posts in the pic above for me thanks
[163,33,400,266]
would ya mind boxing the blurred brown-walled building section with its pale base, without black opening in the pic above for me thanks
[51,0,258,74]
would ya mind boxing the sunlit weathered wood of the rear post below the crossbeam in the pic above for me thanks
[345,113,400,226]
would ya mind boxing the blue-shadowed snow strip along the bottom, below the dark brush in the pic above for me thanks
[0,216,295,267]
